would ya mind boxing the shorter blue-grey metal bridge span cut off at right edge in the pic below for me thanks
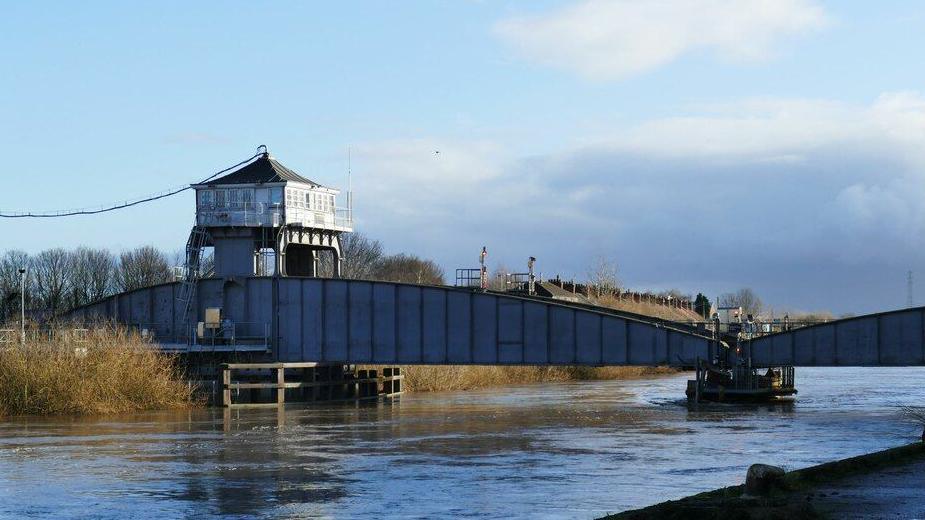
[751,308,925,366]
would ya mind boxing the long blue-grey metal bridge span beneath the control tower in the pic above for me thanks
[70,276,716,366]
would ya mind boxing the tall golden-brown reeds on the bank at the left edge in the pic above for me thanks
[0,329,193,416]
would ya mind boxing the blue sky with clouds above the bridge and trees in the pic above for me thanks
[0,0,925,314]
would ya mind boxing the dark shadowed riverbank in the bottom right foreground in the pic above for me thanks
[605,442,925,520]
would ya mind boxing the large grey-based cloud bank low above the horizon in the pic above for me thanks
[354,92,925,311]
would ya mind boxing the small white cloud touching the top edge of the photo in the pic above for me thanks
[495,0,827,80]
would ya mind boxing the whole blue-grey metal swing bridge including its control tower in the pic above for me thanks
[61,147,925,366]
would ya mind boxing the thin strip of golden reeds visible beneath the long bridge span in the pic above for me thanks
[394,365,676,392]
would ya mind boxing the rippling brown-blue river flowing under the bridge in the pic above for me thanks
[0,368,925,518]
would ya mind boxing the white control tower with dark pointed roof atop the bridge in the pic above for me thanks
[187,147,353,278]
